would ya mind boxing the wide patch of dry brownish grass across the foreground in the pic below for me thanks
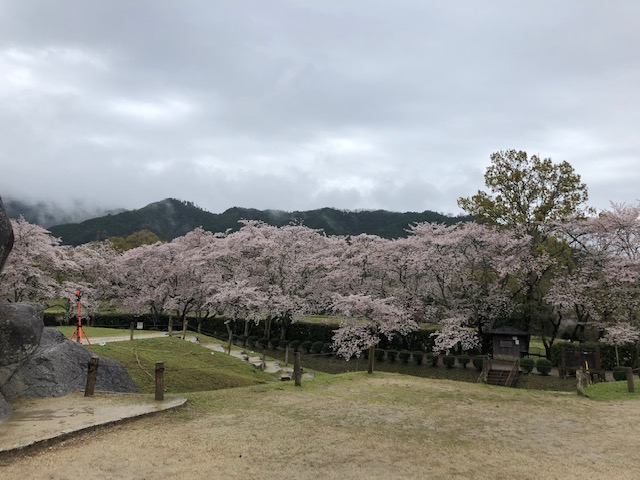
[0,373,640,480]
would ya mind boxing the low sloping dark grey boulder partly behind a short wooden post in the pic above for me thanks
[0,328,136,400]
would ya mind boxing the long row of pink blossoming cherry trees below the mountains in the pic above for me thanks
[0,204,640,357]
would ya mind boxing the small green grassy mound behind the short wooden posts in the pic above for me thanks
[89,337,274,393]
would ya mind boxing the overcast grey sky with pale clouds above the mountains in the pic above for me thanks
[0,0,640,213]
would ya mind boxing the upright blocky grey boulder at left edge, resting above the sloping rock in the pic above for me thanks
[0,303,44,387]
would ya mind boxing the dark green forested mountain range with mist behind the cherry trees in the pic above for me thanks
[5,198,471,245]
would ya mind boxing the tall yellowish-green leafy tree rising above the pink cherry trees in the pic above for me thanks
[458,150,589,344]
